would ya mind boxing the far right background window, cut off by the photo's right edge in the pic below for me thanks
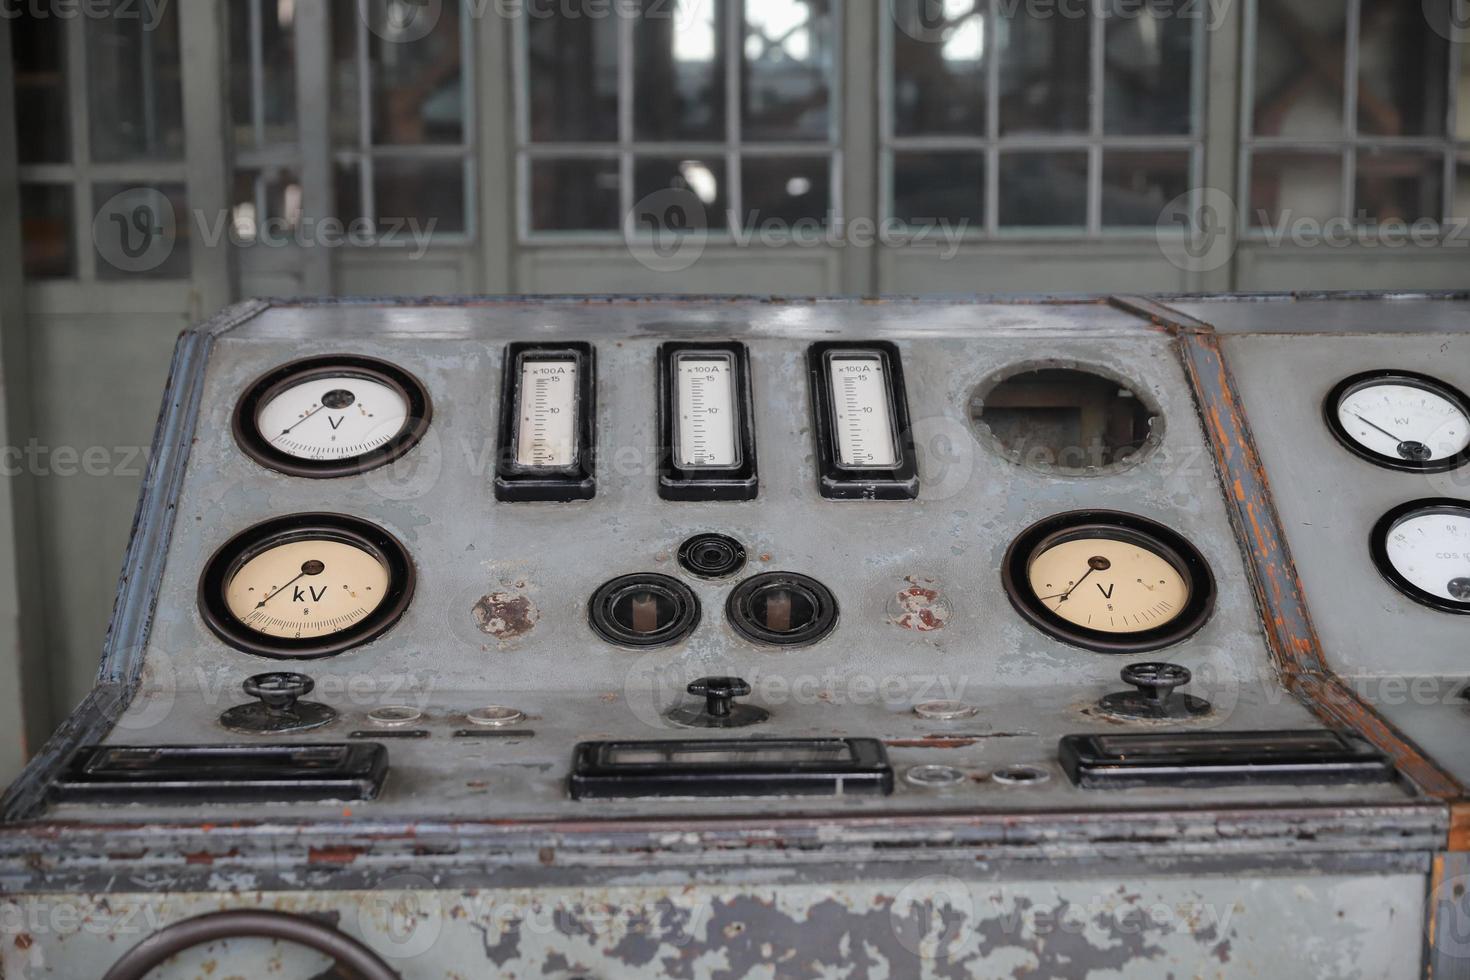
[1242,0,1470,229]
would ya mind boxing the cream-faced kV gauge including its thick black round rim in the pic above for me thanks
[198,514,413,658]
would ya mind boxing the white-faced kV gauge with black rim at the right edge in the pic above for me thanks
[1323,370,1470,473]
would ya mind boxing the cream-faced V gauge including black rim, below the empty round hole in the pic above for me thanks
[1001,510,1214,654]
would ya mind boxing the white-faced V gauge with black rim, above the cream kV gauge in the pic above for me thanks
[235,354,432,478]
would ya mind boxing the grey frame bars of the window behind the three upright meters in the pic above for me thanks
[512,0,848,248]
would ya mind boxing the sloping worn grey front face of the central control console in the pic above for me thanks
[31,301,1410,820]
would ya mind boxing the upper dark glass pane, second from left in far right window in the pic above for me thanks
[1358,0,1449,137]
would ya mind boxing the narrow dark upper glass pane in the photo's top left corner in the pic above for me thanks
[10,9,71,163]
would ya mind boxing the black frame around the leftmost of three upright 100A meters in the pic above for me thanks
[495,341,597,502]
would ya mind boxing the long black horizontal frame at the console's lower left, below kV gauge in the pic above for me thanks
[50,742,388,805]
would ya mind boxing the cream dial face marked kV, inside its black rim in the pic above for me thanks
[225,539,388,638]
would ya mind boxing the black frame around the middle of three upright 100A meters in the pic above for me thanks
[659,341,760,501]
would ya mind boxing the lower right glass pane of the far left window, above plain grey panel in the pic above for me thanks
[91,184,194,281]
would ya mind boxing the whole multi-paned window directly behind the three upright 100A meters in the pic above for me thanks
[517,0,838,239]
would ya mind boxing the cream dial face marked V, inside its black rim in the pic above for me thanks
[1028,536,1189,633]
